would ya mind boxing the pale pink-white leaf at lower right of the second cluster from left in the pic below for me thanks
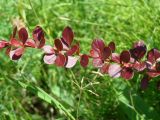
[65,56,78,68]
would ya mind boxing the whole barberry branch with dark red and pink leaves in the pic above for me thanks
[0,26,160,89]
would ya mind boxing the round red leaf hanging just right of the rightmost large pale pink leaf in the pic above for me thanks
[121,67,134,80]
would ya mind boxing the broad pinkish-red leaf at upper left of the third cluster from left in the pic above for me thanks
[92,39,105,53]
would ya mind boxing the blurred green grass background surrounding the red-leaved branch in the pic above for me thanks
[0,0,160,120]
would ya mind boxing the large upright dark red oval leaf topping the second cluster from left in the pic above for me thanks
[62,27,74,46]
